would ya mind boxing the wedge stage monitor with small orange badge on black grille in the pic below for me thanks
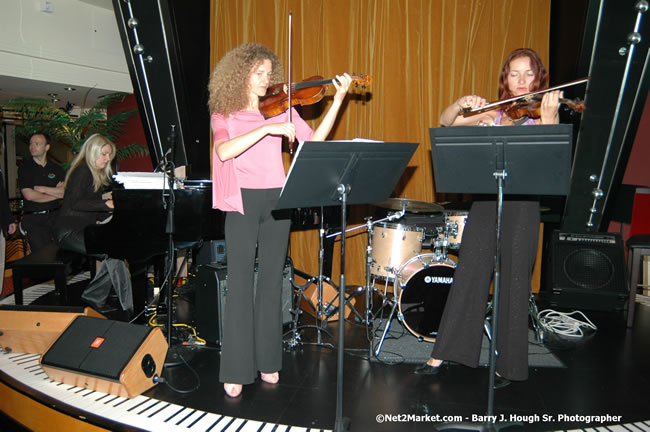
[41,316,168,398]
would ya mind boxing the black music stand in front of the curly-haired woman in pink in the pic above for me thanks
[276,141,417,432]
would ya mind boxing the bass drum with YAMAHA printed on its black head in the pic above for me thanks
[398,254,456,342]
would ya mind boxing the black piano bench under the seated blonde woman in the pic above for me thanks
[6,243,85,305]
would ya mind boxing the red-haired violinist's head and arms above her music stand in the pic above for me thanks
[440,48,563,126]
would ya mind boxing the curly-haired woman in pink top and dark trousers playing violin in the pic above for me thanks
[208,43,351,397]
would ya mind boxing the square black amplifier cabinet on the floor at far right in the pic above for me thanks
[549,231,627,310]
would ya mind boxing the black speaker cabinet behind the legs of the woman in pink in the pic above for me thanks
[194,262,293,344]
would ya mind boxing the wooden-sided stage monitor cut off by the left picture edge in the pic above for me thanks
[0,306,104,354]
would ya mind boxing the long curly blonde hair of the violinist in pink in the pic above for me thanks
[208,42,284,116]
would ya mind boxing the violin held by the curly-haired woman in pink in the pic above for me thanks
[259,75,372,118]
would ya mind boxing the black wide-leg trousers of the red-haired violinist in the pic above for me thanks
[431,201,539,380]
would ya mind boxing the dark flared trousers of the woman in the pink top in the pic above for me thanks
[219,189,291,384]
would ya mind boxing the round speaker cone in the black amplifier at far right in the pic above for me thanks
[564,248,615,290]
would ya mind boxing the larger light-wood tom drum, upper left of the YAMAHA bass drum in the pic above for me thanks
[370,223,424,279]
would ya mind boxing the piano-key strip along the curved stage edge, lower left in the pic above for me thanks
[0,352,330,432]
